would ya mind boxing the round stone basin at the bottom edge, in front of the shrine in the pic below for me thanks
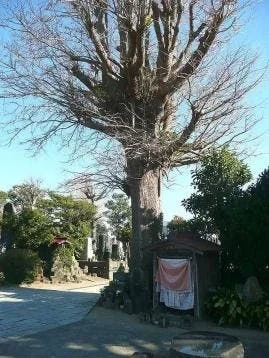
[169,331,244,358]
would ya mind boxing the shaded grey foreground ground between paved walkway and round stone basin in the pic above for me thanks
[0,306,269,358]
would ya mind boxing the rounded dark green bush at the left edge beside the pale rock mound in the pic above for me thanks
[0,249,41,284]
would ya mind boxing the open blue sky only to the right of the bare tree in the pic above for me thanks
[162,0,269,220]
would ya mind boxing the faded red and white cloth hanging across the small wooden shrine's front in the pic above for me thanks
[155,258,194,310]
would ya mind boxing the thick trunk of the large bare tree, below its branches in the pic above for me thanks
[128,163,161,311]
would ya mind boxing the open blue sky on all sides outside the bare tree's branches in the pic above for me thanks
[0,0,269,220]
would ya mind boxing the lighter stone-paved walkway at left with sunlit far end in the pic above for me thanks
[0,278,108,342]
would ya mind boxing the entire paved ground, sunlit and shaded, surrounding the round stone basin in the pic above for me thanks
[0,278,269,358]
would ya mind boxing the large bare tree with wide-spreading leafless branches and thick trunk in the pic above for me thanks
[0,0,257,288]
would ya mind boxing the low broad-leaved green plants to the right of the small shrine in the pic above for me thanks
[205,288,269,330]
